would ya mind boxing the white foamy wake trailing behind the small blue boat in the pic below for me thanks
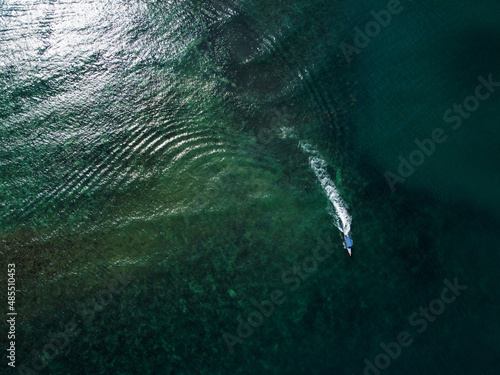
[282,128,352,235]
